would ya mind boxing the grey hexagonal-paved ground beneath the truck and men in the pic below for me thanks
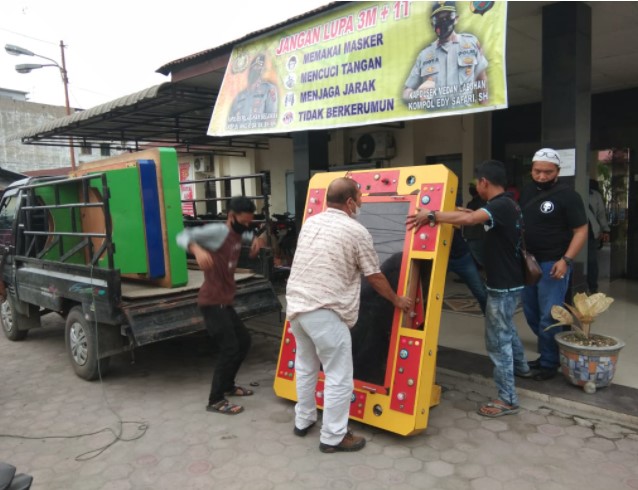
[0,315,638,490]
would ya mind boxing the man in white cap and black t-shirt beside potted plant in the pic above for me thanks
[520,148,587,381]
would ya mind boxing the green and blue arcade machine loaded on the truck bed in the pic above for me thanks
[74,148,188,288]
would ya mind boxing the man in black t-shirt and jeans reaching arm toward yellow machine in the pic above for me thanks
[406,160,531,417]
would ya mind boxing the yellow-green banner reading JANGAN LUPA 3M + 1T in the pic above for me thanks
[208,2,507,136]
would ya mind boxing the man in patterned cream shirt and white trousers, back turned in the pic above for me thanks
[286,178,413,453]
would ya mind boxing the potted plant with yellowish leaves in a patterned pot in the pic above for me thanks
[548,293,625,393]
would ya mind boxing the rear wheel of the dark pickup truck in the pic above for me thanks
[64,306,111,381]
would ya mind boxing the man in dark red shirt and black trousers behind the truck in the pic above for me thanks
[177,196,262,415]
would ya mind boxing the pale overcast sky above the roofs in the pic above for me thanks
[0,0,329,109]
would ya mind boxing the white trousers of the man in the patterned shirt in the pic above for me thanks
[290,309,354,446]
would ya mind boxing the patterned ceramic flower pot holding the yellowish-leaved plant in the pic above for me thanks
[555,331,625,393]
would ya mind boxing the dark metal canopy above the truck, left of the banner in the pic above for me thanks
[9,82,268,155]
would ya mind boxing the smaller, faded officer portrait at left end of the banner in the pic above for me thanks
[226,53,279,129]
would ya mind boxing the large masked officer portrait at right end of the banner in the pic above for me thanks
[403,2,488,111]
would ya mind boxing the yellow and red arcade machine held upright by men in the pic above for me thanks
[274,164,458,435]
